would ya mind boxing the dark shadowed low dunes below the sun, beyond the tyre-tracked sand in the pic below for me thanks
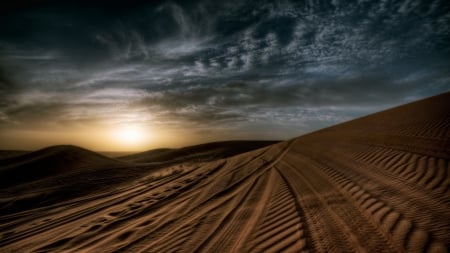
[0,141,276,214]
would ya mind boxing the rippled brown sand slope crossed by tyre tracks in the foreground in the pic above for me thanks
[0,93,450,252]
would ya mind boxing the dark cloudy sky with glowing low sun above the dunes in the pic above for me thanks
[0,0,450,151]
